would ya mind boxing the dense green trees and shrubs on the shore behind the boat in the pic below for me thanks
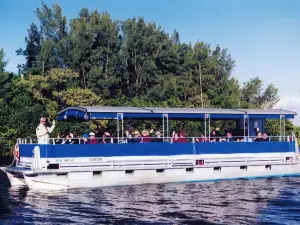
[0,2,300,155]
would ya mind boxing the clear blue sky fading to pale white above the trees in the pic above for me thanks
[0,0,300,125]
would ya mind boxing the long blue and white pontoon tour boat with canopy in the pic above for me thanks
[2,106,300,189]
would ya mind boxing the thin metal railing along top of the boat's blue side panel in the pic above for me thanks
[17,136,293,145]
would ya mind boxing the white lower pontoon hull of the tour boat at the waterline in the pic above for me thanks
[25,164,300,190]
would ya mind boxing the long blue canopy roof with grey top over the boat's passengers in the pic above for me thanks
[57,106,297,120]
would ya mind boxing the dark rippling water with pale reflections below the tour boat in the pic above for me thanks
[0,177,300,224]
